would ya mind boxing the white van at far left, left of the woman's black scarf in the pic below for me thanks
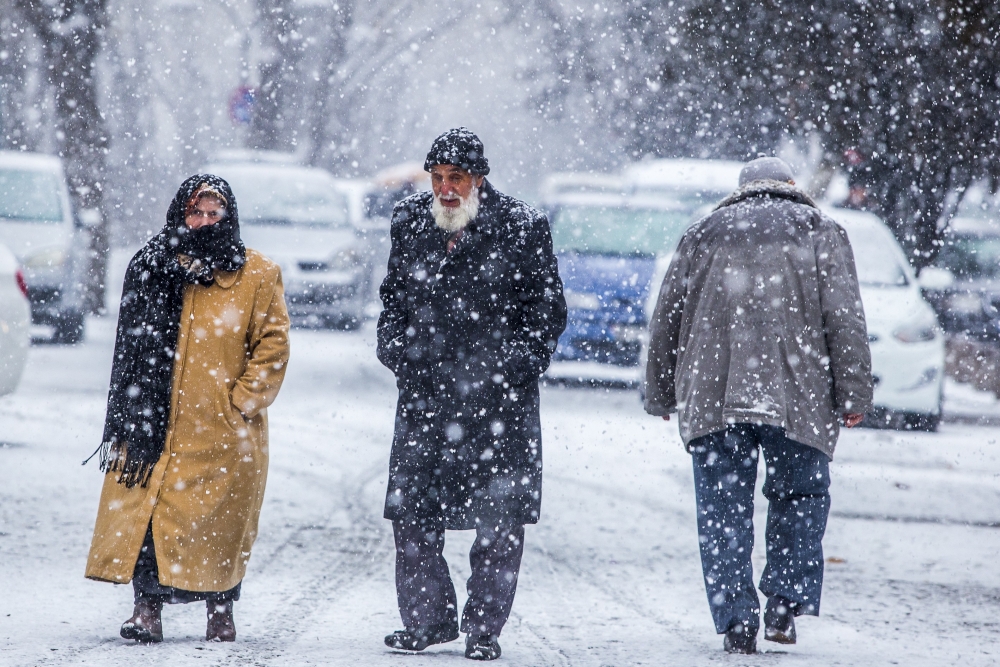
[0,151,89,343]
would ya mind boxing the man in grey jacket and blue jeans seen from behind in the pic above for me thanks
[645,158,873,653]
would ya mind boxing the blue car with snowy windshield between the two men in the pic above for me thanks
[546,193,693,385]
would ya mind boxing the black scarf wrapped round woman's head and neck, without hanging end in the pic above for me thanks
[164,174,246,271]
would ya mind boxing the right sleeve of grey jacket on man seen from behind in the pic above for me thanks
[816,219,873,413]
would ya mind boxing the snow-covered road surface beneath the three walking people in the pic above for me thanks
[0,319,1000,667]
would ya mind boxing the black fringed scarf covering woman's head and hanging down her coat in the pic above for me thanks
[88,174,246,487]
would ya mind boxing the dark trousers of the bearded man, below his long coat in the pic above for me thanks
[392,521,524,635]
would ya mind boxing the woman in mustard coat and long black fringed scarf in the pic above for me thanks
[86,175,288,642]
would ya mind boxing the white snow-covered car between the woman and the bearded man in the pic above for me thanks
[202,157,372,329]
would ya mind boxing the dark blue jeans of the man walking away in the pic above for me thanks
[688,424,830,634]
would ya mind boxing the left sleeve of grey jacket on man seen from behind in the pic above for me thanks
[643,233,692,417]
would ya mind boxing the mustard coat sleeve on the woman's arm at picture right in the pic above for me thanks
[232,266,289,418]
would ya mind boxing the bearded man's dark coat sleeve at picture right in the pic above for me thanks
[502,212,566,384]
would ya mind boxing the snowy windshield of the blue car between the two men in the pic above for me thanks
[552,206,691,255]
